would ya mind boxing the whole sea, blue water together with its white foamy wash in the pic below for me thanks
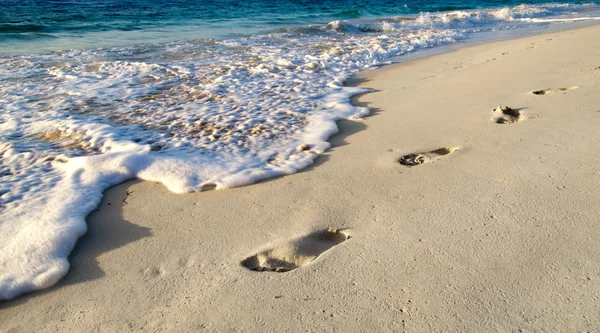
[0,0,600,299]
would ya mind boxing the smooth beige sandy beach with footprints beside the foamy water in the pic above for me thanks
[0,26,600,332]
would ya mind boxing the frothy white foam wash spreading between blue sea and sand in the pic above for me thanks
[0,2,596,299]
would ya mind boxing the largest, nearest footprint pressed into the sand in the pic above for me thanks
[241,228,350,273]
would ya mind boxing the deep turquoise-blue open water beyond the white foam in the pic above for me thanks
[0,0,589,53]
